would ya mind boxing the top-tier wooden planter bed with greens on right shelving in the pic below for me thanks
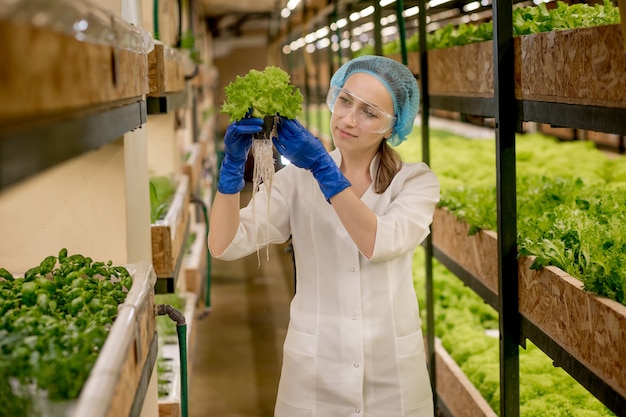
[385,1,626,108]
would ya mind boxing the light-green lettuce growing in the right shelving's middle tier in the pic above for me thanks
[399,130,626,304]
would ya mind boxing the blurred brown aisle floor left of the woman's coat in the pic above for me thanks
[189,184,293,417]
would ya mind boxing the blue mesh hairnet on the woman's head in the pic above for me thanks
[330,55,420,146]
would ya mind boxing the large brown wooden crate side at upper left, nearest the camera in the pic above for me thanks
[0,20,149,123]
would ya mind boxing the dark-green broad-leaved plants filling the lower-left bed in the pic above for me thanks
[0,249,132,400]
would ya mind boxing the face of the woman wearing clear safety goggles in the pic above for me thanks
[330,72,393,152]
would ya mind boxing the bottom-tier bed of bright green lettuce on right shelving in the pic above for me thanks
[413,248,614,417]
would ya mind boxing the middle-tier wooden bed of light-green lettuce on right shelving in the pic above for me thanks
[400,125,626,414]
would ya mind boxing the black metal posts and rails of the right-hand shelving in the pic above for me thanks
[420,0,626,417]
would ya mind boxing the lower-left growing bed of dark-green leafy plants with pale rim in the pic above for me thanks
[0,249,156,417]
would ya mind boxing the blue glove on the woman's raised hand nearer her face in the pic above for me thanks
[273,117,352,200]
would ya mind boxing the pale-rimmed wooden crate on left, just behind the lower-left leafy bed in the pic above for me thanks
[151,175,190,278]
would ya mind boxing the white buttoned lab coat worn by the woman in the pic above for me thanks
[214,150,439,417]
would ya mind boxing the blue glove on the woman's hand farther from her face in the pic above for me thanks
[217,117,263,194]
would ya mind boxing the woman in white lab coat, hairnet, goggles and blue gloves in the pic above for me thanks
[209,56,439,417]
